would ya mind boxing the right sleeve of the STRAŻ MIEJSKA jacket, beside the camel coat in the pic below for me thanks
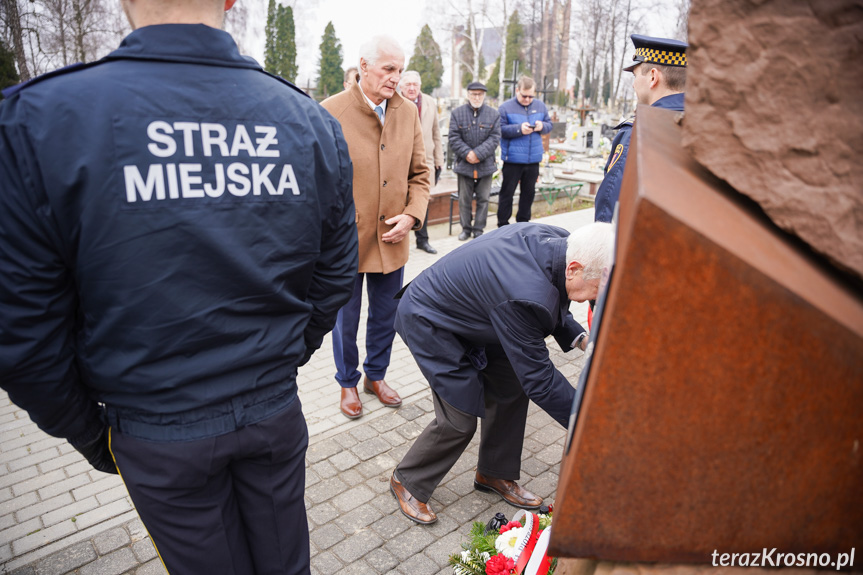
[301,119,359,364]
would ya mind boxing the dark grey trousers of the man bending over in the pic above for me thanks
[395,346,530,503]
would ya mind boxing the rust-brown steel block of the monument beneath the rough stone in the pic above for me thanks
[550,108,863,563]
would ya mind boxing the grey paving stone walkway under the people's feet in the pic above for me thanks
[0,209,593,575]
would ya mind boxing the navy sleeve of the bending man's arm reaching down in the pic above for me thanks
[491,301,575,427]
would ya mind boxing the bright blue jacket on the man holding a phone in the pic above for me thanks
[500,98,552,164]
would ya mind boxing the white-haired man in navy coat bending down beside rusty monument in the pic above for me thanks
[390,223,614,524]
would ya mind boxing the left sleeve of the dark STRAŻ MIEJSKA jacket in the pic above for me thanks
[0,100,103,442]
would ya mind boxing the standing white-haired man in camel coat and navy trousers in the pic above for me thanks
[322,36,429,419]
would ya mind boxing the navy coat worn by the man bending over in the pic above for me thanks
[396,222,584,427]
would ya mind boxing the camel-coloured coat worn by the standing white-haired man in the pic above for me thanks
[321,84,430,274]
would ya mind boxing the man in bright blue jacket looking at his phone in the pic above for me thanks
[497,76,552,227]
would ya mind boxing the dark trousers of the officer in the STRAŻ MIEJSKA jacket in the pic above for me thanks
[110,398,310,575]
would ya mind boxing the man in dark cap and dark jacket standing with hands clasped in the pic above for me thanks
[449,82,500,241]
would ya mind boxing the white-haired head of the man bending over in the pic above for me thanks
[566,222,614,302]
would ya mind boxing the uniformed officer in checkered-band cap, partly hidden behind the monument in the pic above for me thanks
[594,34,687,222]
